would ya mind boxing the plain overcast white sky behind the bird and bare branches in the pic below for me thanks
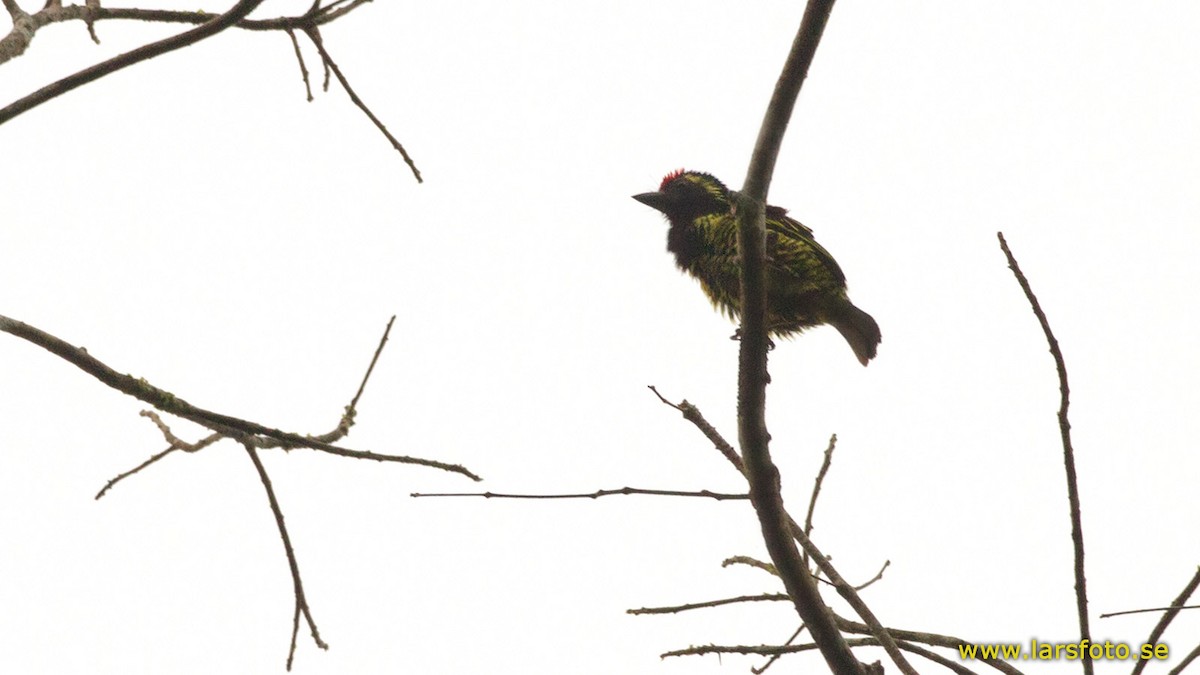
[0,0,1200,674]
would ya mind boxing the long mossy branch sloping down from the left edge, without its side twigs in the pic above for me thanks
[0,316,480,480]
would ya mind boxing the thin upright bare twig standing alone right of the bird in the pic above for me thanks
[996,232,1093,675]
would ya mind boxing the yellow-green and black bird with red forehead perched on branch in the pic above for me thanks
[634,169,882,366]
